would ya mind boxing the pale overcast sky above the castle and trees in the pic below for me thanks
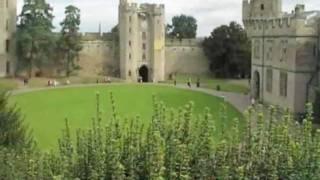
[17,0,320,36]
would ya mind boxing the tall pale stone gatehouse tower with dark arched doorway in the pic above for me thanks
[119,0,165,82]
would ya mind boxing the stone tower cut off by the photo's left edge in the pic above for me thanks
[0,0,17,77]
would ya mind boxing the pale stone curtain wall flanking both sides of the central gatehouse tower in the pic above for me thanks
[79,33,209,77]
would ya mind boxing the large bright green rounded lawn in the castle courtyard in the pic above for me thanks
[11,85,242,150]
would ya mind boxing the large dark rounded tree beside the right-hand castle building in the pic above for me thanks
[203,22,251,78]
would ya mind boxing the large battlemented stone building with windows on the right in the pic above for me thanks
[243,0,320,112]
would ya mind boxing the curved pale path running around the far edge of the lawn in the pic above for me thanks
[11,83,250,112]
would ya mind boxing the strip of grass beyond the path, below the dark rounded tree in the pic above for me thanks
[166,74,249,93]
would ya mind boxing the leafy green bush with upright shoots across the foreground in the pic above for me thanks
[0,93,320,180]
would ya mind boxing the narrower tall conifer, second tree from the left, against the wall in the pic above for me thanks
[59,5,82,76]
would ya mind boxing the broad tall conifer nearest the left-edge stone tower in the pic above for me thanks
[17,0,55,77]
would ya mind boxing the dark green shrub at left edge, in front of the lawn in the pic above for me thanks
[0,92,32,148]
